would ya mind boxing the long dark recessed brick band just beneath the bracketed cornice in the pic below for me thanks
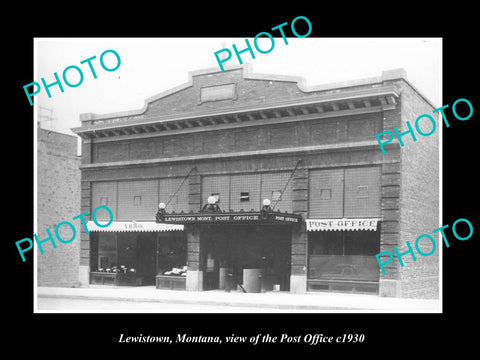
[93,113,382,163]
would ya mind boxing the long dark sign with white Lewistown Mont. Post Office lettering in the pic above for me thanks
[159,211,302,225]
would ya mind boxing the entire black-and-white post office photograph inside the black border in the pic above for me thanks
[31,36,442,314]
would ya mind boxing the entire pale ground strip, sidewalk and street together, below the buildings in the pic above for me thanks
[34,285,442,313]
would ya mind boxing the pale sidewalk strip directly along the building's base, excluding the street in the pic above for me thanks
[36,285,441,313]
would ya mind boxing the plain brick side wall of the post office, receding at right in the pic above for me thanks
[399,82,442,298]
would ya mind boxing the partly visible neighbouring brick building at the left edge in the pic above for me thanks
[35,127,80,286]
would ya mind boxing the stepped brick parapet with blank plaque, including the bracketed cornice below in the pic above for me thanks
[73,65,405,139]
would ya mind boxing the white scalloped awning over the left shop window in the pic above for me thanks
[87,221,183,232]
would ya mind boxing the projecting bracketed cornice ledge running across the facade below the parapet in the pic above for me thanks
[72,85,400,139]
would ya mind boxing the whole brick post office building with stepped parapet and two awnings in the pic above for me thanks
[73,66,439,297]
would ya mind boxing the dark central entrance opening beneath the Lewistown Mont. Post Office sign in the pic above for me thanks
[201,225,291,291]
